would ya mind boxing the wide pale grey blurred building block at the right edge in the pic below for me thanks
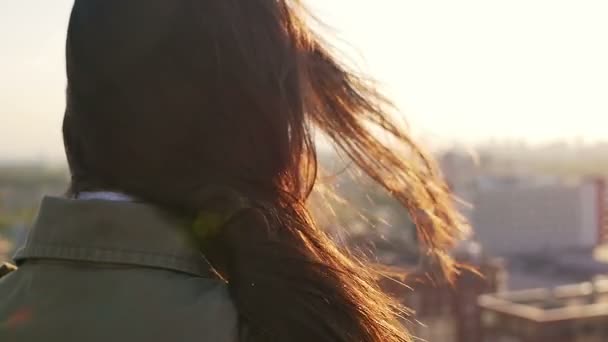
[472,179,608,257]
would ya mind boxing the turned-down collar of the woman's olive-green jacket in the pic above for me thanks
[15,197,211,277]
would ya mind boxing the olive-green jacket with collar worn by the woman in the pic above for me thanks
[0,197,239,342]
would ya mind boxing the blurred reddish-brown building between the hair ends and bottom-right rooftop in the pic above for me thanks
[382,243,506,342]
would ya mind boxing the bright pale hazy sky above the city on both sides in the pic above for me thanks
[0,0,608,160]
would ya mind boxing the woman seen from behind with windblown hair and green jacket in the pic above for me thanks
[0,0,460,342]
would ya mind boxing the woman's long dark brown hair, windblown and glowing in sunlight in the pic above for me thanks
[64,0,461,342]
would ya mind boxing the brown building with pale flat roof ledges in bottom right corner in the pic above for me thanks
[479,279,608,342]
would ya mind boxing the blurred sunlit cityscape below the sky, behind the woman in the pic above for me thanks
[0,141,608,342]
